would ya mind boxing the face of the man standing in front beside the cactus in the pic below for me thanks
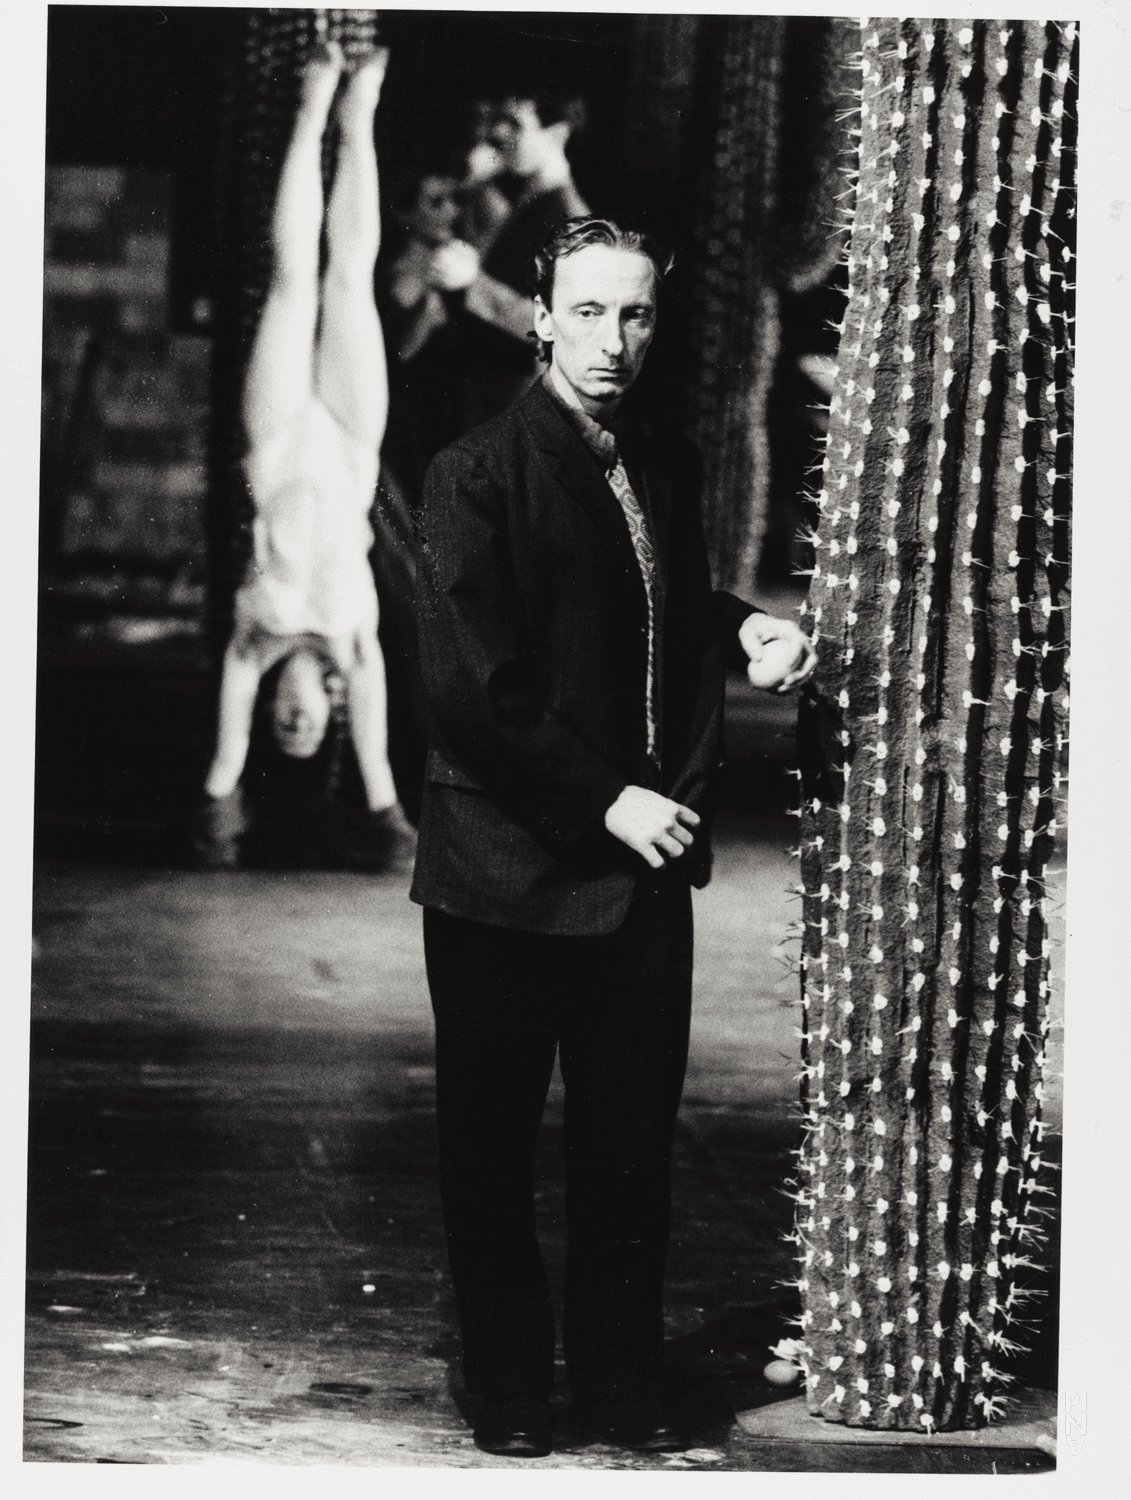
[534,245,656,416]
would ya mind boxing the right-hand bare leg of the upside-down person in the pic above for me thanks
[314,48,389,449]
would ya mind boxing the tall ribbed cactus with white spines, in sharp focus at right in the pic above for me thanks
[797,20,1077,1431]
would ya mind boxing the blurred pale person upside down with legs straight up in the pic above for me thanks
[194,44,416,867]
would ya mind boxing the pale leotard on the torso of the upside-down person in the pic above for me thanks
[236,398,378,639]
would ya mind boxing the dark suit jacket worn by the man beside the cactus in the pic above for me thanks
[411,383,752,935]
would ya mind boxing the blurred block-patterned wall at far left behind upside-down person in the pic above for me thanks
[41,167,210,641]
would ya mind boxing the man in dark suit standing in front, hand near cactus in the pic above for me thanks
[413,219,815,1457]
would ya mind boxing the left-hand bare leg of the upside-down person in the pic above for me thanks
[243,45,342,446]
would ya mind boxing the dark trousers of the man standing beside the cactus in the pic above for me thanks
[425,875,692,1410]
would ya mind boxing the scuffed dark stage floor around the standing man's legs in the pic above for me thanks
[26,654,1053,1475]
